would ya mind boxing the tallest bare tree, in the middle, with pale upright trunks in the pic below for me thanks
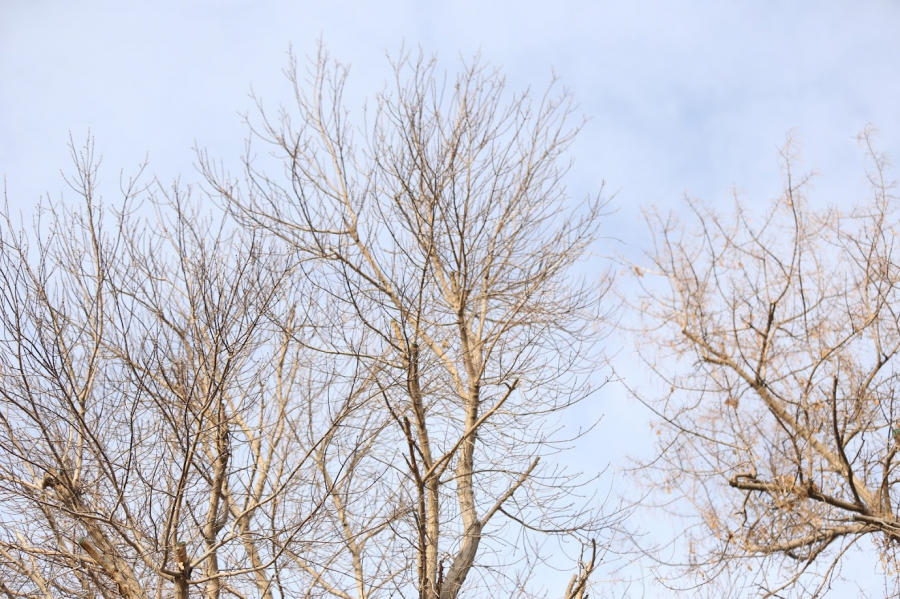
[203,52,610,599]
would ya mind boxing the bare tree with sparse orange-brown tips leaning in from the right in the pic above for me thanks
[636,132,900,597]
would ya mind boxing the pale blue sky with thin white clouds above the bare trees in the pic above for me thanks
[0,0,900,588]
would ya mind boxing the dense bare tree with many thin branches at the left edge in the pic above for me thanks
[0,139,363,599]
